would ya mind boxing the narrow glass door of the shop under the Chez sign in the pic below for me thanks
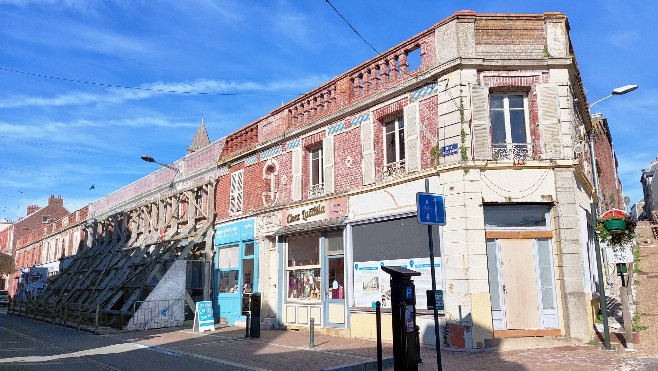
[323,232,345,327]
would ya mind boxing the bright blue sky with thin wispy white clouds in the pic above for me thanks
[0,0,658,220]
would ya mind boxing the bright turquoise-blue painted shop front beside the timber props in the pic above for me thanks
[214,219,258,325]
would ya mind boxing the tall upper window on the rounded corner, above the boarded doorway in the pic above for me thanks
[489,94,530,159]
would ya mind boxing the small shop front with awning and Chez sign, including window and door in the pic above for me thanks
[276,198,347,328]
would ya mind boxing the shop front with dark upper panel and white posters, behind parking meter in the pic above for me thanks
[347,212,444,344]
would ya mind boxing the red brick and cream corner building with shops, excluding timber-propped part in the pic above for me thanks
[210,11,596,348]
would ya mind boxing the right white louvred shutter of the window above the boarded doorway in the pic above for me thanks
[537,84,562,159]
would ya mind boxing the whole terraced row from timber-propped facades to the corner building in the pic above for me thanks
[3,11,616,348]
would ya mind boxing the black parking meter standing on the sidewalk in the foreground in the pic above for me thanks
[382,266,420,371]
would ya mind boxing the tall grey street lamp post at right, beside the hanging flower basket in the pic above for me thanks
[589,85,637,350]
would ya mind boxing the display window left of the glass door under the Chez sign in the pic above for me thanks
[287,235,320,300]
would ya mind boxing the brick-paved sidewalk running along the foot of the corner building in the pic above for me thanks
[106,326,624,371]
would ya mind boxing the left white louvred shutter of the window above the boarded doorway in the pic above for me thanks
[462,84,492,160]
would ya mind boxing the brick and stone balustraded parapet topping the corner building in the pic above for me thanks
[218,11,592,187]
